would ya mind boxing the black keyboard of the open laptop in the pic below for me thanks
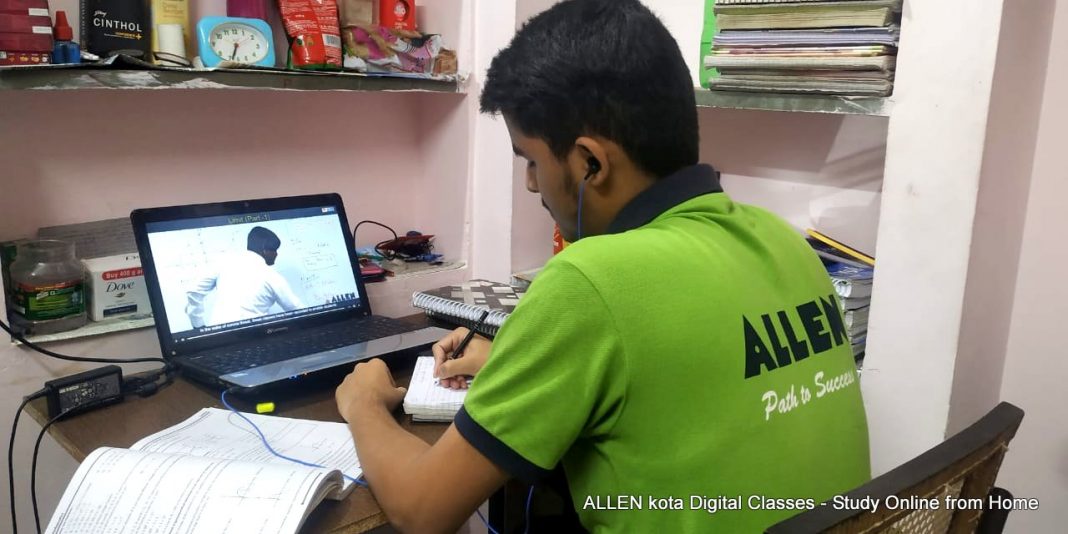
[189,315,418,375]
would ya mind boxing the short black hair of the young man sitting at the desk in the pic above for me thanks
[481,0,700,178]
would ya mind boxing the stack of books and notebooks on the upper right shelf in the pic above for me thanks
[704,0,901,96]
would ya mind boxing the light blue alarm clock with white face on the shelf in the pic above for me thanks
[197,17,274,68]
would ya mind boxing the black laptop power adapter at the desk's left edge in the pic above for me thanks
[45,365,123,418]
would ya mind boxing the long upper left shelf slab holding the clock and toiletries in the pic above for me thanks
[0,66,465,93]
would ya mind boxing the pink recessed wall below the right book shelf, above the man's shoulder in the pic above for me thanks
[700,109,886,253]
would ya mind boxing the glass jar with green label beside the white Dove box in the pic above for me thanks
[11,239,87,335]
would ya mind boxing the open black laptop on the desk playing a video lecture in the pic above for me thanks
[130,193,449,393]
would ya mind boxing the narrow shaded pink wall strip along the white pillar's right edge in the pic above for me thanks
[946,0,1054,435]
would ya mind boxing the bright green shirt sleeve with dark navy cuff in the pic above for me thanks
[455,257,626,482]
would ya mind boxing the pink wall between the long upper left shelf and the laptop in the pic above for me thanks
[0,91,466,255]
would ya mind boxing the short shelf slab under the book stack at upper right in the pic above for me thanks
[694,89,891,116]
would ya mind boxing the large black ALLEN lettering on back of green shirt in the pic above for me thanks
[741,294,849,378]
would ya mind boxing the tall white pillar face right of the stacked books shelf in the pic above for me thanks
[861,0,1002,474]
